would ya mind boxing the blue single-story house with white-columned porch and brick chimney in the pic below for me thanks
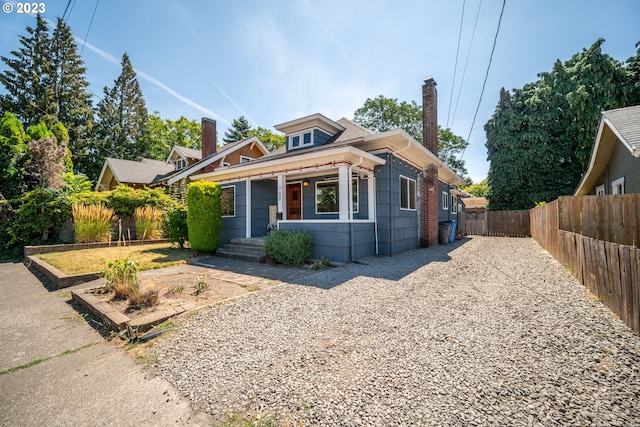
[190,79,464,262]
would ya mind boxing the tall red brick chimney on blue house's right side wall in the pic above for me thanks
[418,78,440,247]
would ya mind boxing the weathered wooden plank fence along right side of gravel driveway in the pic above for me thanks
[531,194,640,335]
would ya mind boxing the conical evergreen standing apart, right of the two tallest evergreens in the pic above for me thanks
[92,53,148,180]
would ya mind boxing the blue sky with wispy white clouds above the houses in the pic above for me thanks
[0,0,640,182]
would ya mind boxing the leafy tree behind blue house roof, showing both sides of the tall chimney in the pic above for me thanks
[353,95,469,180]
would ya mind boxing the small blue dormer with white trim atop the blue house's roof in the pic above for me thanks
[274,113,345,152]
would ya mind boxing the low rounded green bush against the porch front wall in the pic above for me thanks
[264,230,313,265]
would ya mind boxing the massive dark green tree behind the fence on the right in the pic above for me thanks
[485,39,631,210]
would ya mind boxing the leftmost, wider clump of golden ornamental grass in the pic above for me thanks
[71,204,113,243]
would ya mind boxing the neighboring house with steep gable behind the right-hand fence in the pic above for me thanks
[574,105,640,196]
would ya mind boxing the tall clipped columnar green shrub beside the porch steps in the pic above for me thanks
[187,181,222,252]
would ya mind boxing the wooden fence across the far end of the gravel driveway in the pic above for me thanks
[464,210,531,237]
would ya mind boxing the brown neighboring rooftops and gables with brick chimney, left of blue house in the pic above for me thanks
[96,118,269,191]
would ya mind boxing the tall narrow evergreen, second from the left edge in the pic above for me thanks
[52,18,93,176]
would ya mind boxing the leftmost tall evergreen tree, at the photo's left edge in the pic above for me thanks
[0,15,57,125]
